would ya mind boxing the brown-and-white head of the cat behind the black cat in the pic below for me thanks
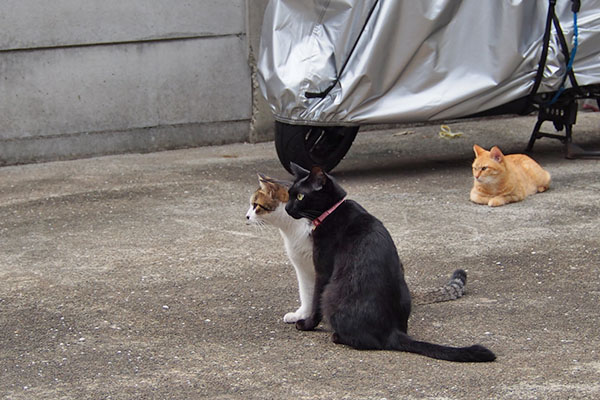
[246,174,288,225]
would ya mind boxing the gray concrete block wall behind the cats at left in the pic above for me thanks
[0,0,270,165]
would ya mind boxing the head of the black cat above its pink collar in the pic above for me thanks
[285,163,346,220]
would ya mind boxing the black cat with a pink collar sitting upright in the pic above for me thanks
[285,163,496,362]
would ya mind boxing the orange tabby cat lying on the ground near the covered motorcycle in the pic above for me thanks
[471,145,550,207]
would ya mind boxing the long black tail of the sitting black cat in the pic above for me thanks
[389,330,496,362]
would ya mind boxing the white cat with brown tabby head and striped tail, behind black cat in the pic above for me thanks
[246,174,467,324]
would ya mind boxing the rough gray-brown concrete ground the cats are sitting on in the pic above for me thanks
[0,113,600,399]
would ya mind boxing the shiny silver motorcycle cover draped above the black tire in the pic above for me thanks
[258,0,600,125]
